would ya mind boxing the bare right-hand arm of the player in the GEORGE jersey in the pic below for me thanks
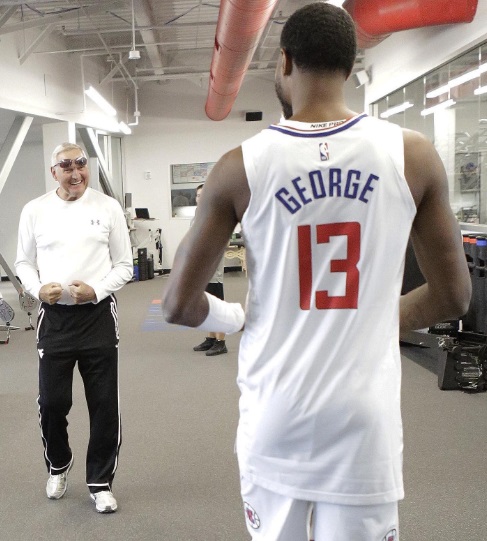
[400,130,471,333]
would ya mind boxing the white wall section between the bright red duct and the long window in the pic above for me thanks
[365,0,487,104]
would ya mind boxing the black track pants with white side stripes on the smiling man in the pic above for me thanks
[38,299,122,492]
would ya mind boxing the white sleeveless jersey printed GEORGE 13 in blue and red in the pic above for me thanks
[237,114,416,505]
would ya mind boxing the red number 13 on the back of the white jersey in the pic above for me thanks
[298,222,360,310]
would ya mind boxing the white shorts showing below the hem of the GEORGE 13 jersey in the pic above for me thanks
[240,478,399,541]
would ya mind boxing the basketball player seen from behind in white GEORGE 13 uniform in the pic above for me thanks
[164,2,471,541]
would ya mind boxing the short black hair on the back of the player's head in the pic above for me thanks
[281,2,357,77]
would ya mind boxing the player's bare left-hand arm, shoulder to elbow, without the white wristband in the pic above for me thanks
[163,147,250,326]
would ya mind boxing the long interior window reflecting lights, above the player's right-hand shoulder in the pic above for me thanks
[372,44,487,224]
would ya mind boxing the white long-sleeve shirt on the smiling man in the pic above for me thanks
[15,188,133,304]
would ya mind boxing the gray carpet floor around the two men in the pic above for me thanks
[0,272,487,541]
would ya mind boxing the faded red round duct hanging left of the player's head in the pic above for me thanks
[205,0,278,120]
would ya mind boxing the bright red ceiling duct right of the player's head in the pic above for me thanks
[343,0,478,49]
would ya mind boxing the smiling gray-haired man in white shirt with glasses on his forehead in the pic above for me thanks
[15,143,133,513]
